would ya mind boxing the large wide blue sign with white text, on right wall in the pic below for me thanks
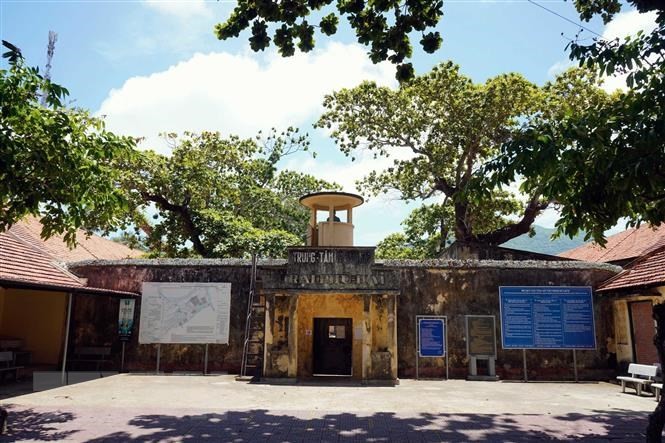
[499,286,596,349]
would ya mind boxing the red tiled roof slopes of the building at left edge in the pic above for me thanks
[0,218,141,295]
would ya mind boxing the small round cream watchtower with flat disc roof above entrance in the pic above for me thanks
[300,192,364,246]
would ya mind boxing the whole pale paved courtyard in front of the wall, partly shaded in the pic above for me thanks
[0,374,656,442]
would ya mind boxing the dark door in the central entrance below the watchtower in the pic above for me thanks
[314,318,353,376]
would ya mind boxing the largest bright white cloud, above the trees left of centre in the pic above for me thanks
[98,43,395,153]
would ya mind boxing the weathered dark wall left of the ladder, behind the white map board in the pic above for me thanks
[71,260,260,372]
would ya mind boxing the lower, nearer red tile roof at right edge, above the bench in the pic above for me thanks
[598,246,665,291]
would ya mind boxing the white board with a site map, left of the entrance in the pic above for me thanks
[139,282,231,344]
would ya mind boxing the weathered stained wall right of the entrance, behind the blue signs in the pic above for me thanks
[386,261,616,379]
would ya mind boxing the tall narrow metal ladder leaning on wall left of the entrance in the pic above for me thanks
[238,254,266,380]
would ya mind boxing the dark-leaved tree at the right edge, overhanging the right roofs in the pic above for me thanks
[556,5,665,442]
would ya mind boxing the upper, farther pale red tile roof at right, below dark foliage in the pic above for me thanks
[559,224,665,262]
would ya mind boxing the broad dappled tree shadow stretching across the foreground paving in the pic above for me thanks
[0,409,647,442]
